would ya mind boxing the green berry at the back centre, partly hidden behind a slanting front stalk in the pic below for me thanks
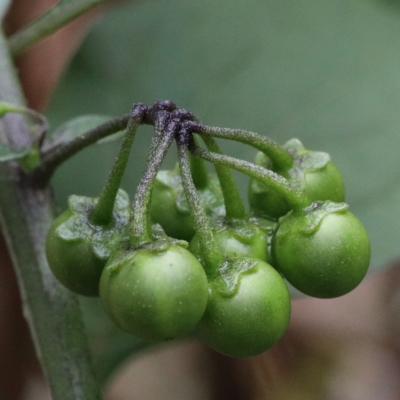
[150,167,225,242]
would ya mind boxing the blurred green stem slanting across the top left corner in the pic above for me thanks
[8,0,106,56]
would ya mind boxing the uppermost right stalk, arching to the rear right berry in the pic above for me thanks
[196,125,293,171]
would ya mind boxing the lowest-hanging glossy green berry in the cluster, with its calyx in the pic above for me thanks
[198,258,291,357]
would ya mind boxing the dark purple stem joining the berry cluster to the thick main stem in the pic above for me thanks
[33,114,131,187]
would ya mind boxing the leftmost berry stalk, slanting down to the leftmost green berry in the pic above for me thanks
[90,104,145,225]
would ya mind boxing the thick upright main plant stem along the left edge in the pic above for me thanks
[0,29,100,400]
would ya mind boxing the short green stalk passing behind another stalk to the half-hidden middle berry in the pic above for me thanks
[203,136,246,219]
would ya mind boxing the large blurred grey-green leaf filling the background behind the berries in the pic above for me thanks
[41,0,400,388]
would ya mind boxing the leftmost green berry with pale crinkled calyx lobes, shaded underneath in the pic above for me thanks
[46,189,130,296]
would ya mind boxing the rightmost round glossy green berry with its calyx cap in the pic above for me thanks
[272,202,370,298]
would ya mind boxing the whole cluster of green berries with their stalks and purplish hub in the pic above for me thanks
[46,101,370,357]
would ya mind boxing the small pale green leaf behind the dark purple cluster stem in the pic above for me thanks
[48,114,124,146]
